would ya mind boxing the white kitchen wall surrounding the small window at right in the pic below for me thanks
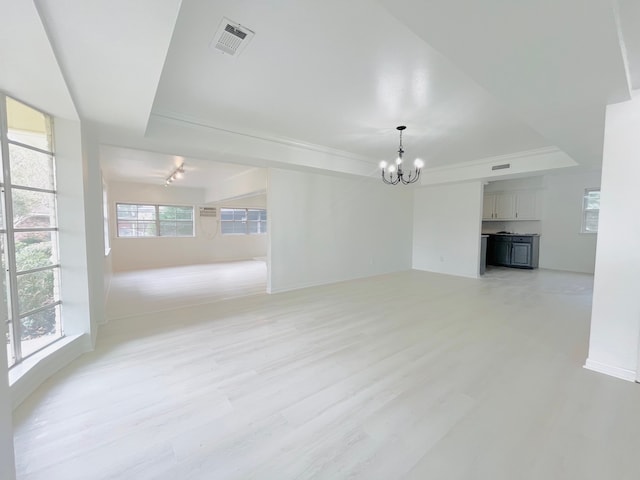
[540,171,600,273]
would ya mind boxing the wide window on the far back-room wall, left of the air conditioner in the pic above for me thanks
[116,203,194,237]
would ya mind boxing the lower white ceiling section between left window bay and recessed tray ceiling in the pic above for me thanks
[36,0,180,134]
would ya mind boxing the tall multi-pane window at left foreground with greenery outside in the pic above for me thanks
[0,94,63,366]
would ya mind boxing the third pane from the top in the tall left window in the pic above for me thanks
[12,188,56,228]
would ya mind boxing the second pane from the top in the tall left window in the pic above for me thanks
[9,144,54,190]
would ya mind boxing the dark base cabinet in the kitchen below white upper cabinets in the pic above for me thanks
[487,235,540,268]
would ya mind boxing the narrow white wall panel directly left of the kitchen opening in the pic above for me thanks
[413,181,483,278]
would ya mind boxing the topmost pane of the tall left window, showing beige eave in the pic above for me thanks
[7,97,53,152]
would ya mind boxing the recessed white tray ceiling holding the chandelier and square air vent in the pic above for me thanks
[154,0,548,165]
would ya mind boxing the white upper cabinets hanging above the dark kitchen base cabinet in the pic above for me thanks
[482,190,539,220]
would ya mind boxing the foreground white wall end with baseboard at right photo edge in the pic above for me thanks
[586,96,640,380]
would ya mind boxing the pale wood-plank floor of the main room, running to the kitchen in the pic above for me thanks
[15,268,640,480]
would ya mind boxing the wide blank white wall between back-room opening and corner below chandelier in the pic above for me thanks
[267,169,413,292]
